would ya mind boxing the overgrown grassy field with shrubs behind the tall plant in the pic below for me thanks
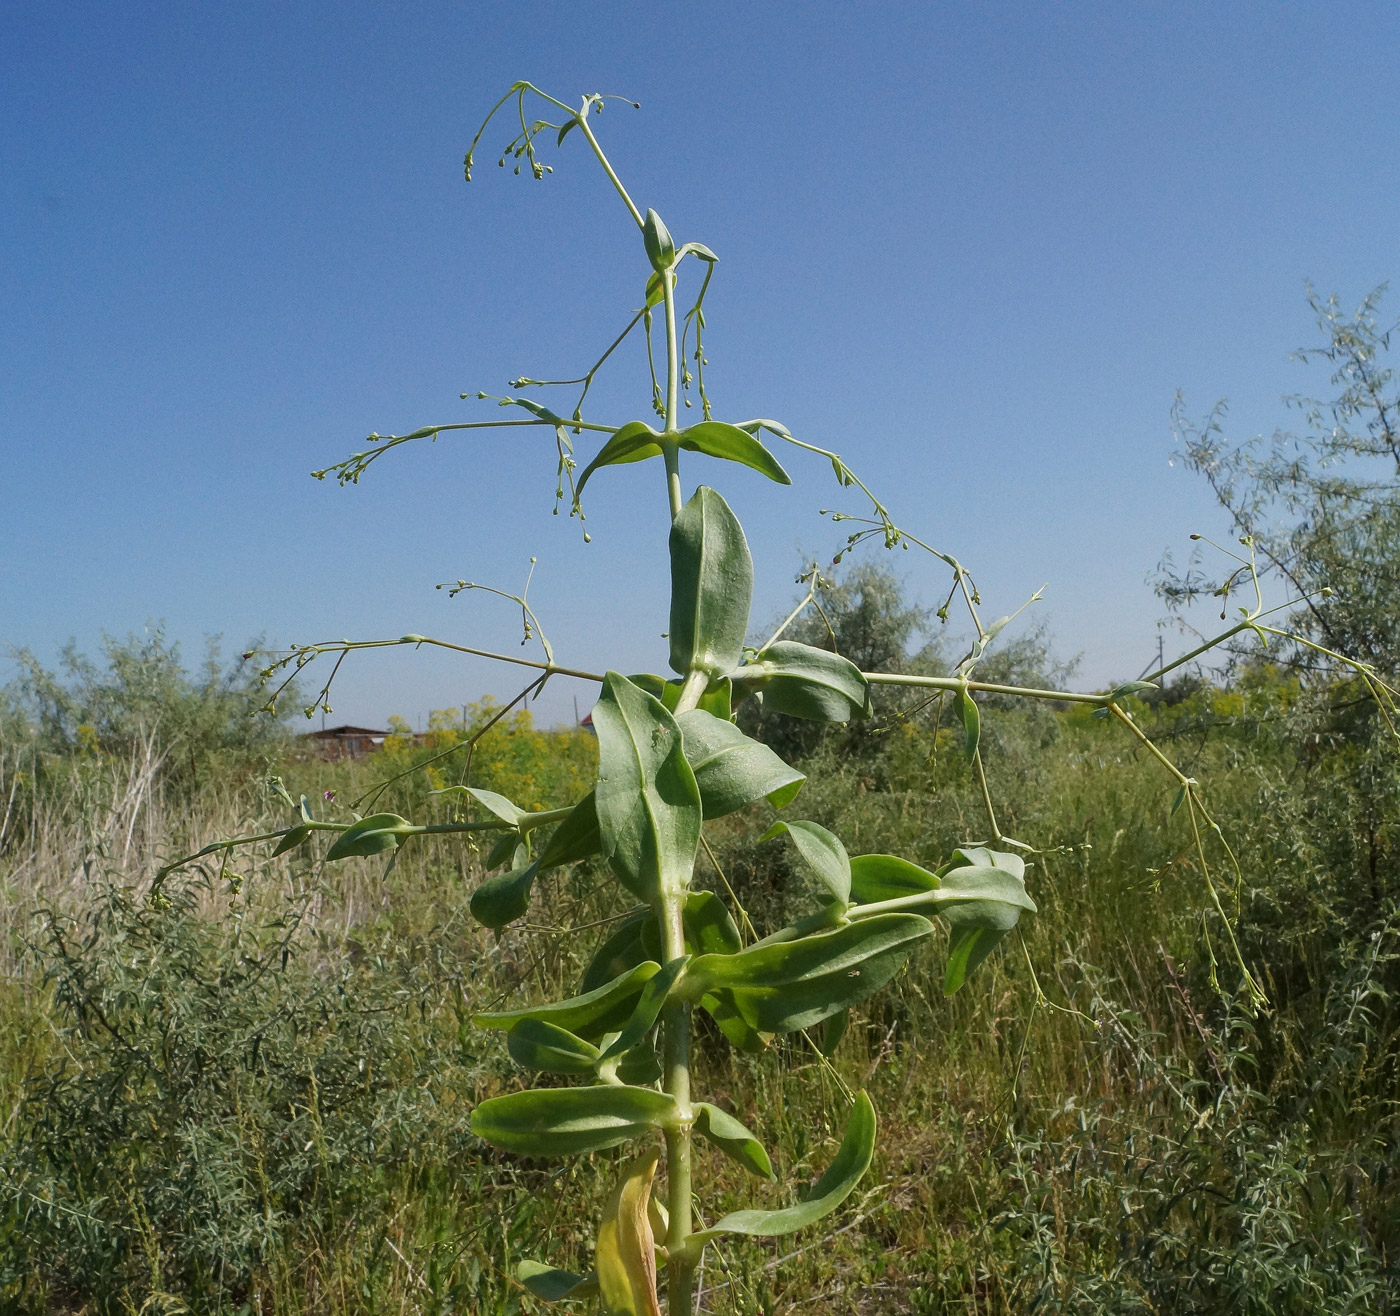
[0,672,1400,1316]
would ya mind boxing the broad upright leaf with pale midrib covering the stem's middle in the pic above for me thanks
[594,672,701,903]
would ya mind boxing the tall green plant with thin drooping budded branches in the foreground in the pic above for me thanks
[161,83,1388,1316]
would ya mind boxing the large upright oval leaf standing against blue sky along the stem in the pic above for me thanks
[671,490,753,679]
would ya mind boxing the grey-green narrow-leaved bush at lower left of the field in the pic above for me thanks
[0,879,476,1312]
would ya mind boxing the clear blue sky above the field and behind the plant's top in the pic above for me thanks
[0,0,1400,722]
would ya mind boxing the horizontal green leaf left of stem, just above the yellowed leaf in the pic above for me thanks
[472,1084,676,1158]
